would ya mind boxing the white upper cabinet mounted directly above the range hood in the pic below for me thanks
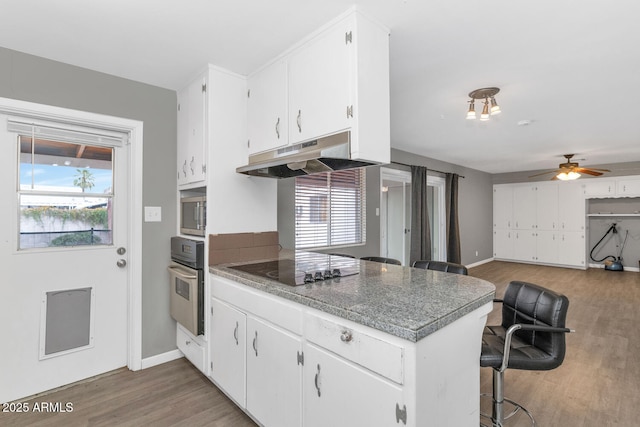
[248,10,390,163]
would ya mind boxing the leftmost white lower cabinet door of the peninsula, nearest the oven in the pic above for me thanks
[209,298,246,407]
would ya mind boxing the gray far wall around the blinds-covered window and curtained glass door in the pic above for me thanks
[278,149,493,265]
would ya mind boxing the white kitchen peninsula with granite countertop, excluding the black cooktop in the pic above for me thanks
[208,251,495,427]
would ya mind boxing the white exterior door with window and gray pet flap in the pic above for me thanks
[0,110,137,402]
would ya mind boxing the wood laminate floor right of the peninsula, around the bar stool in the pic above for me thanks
[469,261,640,427]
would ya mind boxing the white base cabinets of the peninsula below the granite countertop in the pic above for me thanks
[208,274,492,427]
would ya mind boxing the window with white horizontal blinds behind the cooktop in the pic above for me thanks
[295,168,366,249]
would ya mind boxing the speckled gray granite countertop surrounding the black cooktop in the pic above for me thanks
[209,251,495,342]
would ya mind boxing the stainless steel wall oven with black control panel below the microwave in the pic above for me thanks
[168,236,204,336]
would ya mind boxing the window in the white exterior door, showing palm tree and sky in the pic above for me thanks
[18,135,114,249]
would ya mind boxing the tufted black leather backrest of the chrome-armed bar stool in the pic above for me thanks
[502,280,569,369]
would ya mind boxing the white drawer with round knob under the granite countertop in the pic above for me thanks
[304,313,404,384]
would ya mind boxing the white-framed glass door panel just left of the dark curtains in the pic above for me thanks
[380,168,411,265]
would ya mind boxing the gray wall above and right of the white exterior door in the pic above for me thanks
[0,48,177,357]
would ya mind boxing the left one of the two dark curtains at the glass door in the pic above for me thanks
[409,166,431,264]
